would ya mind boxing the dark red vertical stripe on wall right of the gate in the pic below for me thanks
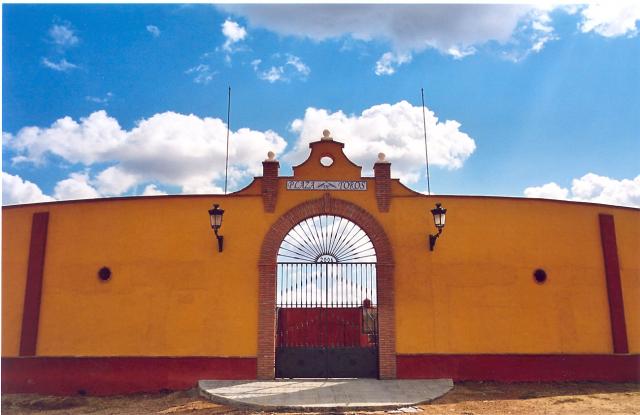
[599,214,629,353]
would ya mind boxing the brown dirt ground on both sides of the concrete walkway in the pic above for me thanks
[2,382,640,415]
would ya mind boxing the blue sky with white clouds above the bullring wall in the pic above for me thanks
[2,2,640,206]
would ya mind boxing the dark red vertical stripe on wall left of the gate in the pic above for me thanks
[20,212,49,356]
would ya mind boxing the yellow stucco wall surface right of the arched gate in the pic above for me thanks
[390,197,640,353]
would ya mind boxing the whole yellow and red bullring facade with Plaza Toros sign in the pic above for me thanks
[2,133,640,394]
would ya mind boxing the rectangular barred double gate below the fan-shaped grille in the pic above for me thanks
[276,262,378,378]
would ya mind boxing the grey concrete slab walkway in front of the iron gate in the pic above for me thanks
[198,379,453,410]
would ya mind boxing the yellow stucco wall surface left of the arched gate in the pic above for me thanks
[2,185,267,356]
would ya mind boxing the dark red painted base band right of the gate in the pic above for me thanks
[397,354,640,382]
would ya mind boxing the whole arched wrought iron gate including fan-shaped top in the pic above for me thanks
[276,215,378,378]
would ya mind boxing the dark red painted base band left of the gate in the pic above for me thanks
[2,357,256,395]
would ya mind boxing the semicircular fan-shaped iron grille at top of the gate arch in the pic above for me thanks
[278,215,376,264]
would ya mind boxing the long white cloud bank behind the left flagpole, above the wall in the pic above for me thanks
[3,111,286,198]
